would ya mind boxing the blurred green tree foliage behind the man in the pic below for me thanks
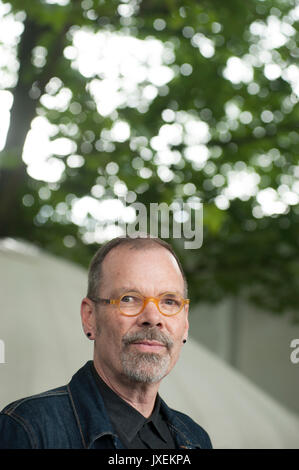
[0,0,299,316]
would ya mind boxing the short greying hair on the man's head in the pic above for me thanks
[87,234,188,299]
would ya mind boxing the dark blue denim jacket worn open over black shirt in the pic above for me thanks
[0,361,212,449]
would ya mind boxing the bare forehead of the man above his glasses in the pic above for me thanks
[101,246,184,295]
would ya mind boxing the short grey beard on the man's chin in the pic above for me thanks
[121,347,170,384]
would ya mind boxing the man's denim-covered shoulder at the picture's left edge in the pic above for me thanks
[0,386,69,448]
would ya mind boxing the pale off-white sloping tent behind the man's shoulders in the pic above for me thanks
[0,239,299,449]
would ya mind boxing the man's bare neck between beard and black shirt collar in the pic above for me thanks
[93,357,160,418]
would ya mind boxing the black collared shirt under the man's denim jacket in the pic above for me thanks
[92,363,176,449]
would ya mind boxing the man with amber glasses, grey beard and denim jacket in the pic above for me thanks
[0,236,211,449]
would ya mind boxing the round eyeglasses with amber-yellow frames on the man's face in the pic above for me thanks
[89,292,190,317]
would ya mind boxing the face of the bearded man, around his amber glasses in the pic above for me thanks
[82,246,188,383]
